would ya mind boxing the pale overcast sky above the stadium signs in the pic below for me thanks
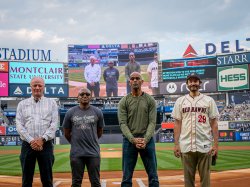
[0,0,250,62]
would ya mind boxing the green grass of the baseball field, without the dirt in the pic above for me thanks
[0,142,250,175]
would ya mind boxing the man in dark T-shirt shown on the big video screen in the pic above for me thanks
[103,60,119,97]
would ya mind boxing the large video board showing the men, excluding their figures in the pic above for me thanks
[68,42,159,97]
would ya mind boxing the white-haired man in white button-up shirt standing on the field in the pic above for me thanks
[16,77,58,187]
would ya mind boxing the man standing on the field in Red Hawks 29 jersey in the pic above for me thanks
[172,73,219,187]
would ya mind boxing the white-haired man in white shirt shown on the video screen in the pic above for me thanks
[84,56,102,97]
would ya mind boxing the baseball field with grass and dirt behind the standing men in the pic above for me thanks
[0,142,250,187]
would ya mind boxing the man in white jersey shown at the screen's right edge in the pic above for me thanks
[147,52,159,95]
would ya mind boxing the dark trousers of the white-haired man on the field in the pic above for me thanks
[20,141,54,187]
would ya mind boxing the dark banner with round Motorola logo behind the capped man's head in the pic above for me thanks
[159,79,217,94]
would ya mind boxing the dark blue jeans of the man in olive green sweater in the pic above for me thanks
[121,137,159,187]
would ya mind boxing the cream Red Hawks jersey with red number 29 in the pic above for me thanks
[172,94,219,153]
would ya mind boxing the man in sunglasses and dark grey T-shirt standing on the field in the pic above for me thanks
[63,88,105,187]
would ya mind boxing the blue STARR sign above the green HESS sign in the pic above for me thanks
[217,52,250,66]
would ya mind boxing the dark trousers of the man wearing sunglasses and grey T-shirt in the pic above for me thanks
[70,157,101,187]
